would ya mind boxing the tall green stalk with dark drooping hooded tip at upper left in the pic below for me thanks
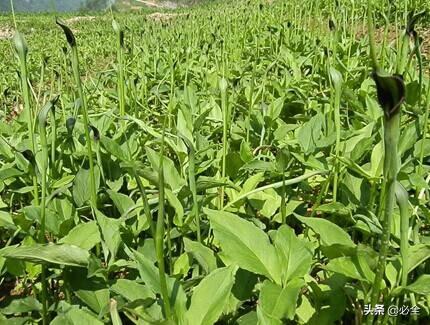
[57,19,97,208]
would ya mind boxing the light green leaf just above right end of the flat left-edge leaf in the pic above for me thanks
[59,221,100,250]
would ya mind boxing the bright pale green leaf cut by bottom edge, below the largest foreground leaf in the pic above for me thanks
[185,266,237,325]
